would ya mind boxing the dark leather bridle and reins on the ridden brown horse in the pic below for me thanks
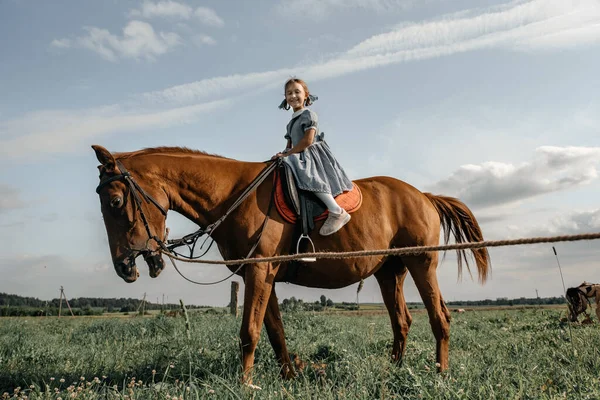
[96,158,283,285]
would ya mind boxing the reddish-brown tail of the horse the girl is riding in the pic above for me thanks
[423,193,492,283]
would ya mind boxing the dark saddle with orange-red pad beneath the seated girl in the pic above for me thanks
[274,163,362,230]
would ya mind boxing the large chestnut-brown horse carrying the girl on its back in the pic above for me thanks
[92,146,490,383]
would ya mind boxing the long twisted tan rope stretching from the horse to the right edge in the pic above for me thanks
[162,232,600,265]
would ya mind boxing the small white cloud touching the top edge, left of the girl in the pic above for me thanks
[129,0,225,27]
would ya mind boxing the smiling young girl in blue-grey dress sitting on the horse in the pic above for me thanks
[273,78,352,236]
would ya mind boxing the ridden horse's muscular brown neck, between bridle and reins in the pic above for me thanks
[133,154,261,226]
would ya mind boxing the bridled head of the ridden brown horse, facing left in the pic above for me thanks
[92,146,168,283]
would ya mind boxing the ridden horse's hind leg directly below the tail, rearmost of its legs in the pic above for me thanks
[402,252,450,371]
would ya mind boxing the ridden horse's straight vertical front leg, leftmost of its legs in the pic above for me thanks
[240,263,275,384]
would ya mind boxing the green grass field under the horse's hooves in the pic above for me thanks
[0,308,600,400]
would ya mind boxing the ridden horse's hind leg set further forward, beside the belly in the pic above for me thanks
[375,257,412,364]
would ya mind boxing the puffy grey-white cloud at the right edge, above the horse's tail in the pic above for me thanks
[429,146,600,207]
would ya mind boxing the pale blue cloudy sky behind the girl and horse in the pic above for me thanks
[0,0,600,305]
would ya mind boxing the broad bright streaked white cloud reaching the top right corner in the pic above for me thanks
[348,0,600,57]
